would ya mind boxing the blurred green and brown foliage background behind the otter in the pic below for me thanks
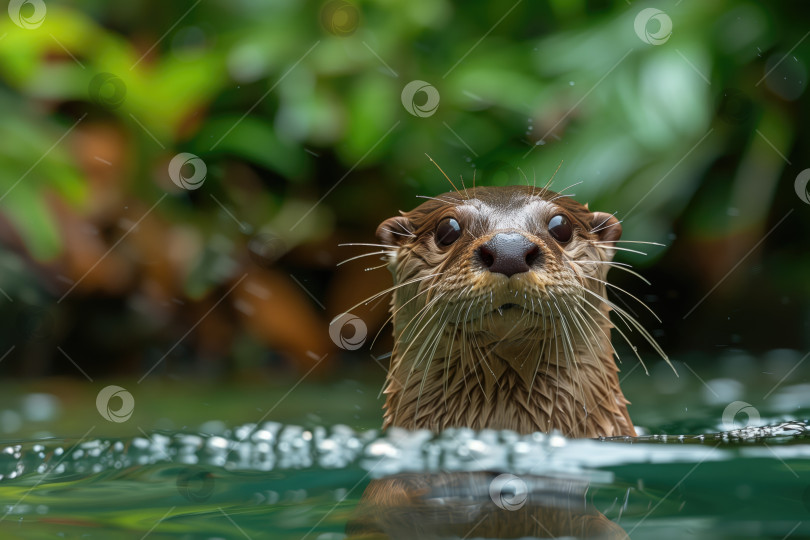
[0,0,810,433]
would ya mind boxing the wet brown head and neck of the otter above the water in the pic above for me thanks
[377,186,651,436]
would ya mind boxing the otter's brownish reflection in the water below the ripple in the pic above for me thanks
[346,472,627,540]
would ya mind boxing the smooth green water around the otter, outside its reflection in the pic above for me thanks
[0,351,810,540]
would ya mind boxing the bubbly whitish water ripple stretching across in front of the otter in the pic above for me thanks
[0,421,810,483]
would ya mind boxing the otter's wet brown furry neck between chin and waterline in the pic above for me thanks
[384,284,636,437]
